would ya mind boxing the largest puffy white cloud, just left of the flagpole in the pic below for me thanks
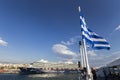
[52,44,77,58]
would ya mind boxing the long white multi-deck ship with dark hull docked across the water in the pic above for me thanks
[20,61,80,74]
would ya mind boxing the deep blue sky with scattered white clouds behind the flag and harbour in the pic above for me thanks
[0,0,120,66]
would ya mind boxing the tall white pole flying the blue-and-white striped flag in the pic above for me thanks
[78,6,92,80]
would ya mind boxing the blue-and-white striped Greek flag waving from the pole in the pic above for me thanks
[80,9,110,50]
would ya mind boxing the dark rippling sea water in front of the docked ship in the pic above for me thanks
[0,74,79,80]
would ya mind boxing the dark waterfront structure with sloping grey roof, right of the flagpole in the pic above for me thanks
[97,59,120,80]
